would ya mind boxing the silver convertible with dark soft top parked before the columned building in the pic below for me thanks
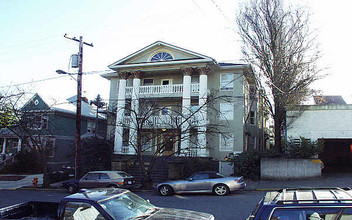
[155,171,246,196]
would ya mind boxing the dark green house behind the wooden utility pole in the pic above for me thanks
[0,94,106,170]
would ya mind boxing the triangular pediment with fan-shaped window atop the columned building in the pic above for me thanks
[109,41,213,68]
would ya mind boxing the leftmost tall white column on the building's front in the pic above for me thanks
[114,73,128,154]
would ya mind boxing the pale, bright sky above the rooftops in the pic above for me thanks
[0,0,352,104]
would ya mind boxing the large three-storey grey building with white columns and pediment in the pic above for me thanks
[103,41,264,160]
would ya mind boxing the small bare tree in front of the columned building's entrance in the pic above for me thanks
[110,93,230,185]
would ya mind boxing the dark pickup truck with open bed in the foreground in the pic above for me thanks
[0,188,214,220]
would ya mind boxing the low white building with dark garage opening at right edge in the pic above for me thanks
[287,96,352,166]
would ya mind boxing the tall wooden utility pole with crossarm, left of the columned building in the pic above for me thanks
[64,34,93,179]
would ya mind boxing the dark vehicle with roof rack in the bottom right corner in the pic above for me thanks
[247,188,352,220]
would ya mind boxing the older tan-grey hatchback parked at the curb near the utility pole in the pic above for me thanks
[63,171,136,193]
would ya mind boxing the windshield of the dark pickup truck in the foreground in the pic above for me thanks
[99,192,156,219]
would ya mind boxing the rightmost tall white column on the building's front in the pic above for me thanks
[197,67,210,157]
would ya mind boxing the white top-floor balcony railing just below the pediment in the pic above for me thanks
[126,84,199,96]
